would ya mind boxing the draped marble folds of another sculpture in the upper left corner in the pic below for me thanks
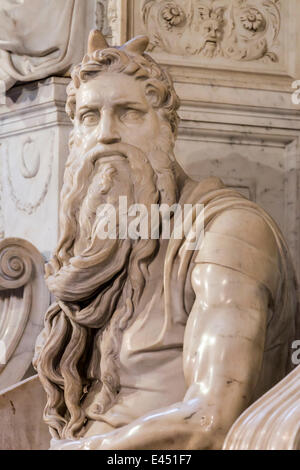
[0,0,96,91]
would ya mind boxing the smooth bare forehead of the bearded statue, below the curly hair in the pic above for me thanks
[76,72,148,109]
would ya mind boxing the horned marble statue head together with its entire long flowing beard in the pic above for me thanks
[38,31,184,437]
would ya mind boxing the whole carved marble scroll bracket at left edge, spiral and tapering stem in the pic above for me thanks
[0,238,50,390]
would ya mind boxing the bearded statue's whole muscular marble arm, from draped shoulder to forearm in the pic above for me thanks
[54,210,278,450]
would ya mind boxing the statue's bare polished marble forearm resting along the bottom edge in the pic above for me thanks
[54,399,225,450]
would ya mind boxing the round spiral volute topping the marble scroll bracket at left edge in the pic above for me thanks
[0,241,33,290]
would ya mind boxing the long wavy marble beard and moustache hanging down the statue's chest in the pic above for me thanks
[36,129,177,439]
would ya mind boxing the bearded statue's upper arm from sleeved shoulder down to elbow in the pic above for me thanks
[184,210,280,409]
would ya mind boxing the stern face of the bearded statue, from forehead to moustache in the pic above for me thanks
[75,73,160,153]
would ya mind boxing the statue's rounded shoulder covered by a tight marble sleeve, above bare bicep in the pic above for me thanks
[192,208,281,295]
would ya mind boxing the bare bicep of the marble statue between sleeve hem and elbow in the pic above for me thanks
[184,264,268,393]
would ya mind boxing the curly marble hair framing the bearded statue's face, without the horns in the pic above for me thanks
[66,47,180,138]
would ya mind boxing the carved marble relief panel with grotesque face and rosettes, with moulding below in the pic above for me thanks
[132,0,300,91]
